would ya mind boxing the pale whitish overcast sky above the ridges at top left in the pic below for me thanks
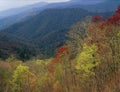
[0,0,69,11]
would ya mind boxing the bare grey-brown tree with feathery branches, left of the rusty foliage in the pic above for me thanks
[66,16,92,58]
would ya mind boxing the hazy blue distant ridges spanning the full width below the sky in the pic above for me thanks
[0,0,120,18]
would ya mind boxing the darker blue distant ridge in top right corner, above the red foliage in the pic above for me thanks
[67,0,120,12]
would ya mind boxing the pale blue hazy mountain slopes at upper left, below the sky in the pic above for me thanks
[0,3,47,30]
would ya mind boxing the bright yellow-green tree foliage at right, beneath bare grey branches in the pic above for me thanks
[76,44,99,76]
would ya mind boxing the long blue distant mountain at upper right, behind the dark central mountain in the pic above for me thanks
[44,0,120,13]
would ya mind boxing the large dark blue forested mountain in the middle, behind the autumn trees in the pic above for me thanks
[2,8,111,56]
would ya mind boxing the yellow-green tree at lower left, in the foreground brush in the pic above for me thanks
[13,65,36,92]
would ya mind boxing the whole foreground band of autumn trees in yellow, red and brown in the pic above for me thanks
[0,7,120,92]
